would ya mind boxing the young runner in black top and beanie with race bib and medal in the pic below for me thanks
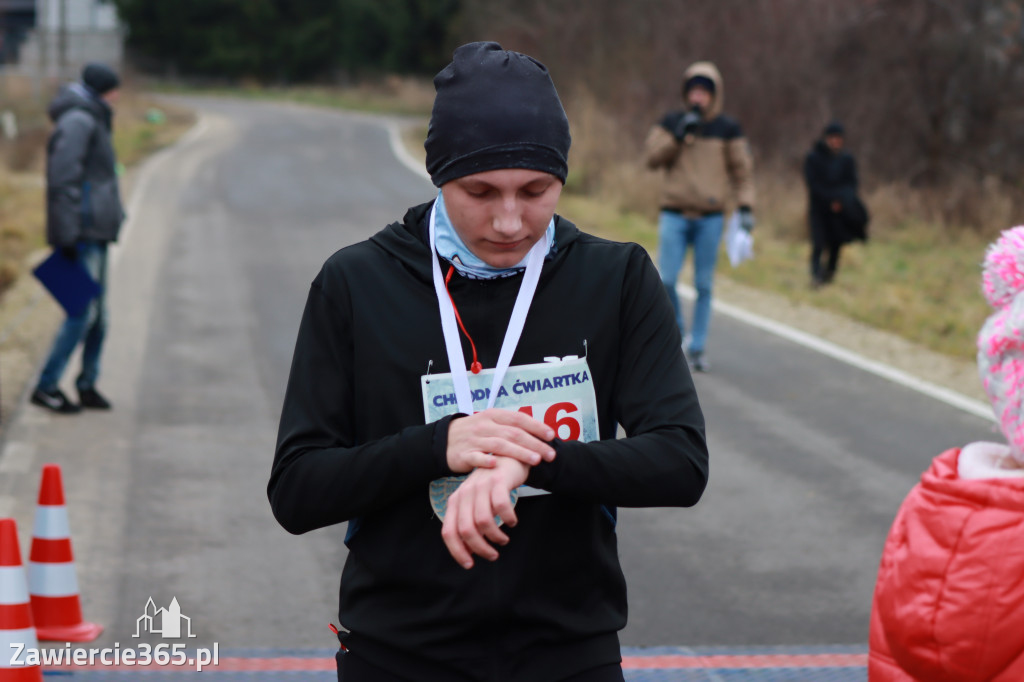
[267,43,708,682]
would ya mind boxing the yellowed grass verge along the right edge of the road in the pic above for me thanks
[559,162,991,358]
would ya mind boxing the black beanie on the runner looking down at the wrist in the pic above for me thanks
[423,42,572,187]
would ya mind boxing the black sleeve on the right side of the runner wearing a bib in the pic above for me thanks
[526,247,708,507]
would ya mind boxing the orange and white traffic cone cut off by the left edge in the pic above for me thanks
[0,518,43,682]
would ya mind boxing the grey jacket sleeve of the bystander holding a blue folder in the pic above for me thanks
[46,111,96,247]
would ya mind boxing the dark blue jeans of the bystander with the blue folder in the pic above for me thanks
[38,242,106,391]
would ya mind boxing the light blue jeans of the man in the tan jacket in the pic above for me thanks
[657,211,722,353]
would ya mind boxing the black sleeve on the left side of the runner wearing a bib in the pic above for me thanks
[267,272,451,535]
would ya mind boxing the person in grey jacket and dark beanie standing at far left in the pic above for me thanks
[31,63,125,414]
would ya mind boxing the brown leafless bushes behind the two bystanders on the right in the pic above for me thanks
[461,0,1024,231]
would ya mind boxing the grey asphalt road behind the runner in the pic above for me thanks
[0,99,996,648]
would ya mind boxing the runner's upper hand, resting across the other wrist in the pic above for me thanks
[446,408,555,473]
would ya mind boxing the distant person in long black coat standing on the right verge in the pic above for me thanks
[804,122,867,288]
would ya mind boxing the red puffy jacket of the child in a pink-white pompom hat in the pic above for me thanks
[868,449,1024,682]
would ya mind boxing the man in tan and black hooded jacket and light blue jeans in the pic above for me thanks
[644,61,755,372]
